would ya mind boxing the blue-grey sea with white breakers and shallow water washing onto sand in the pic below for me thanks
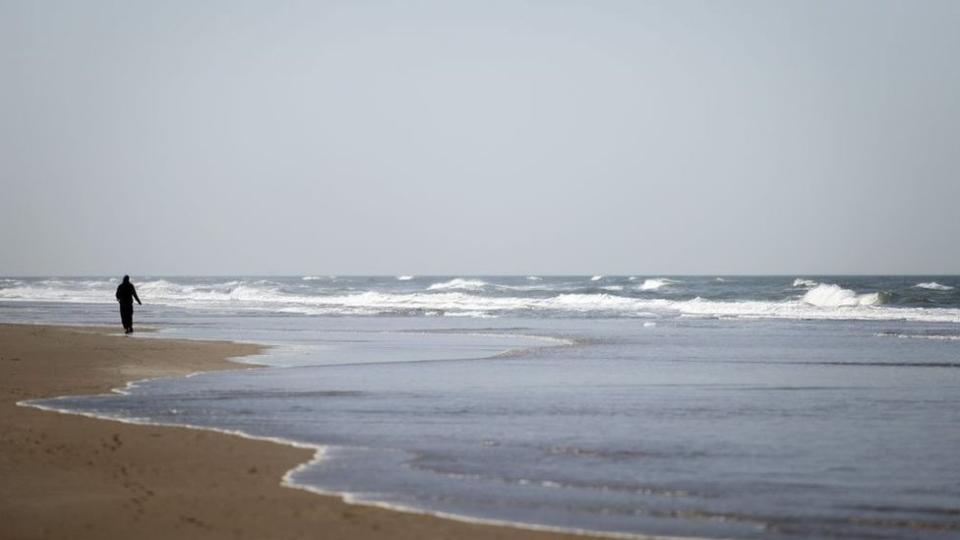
[0,275,960,539]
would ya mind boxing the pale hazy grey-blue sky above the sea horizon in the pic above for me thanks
[0,0,960,275]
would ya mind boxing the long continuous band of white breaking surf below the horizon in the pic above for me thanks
[0,278,960,323]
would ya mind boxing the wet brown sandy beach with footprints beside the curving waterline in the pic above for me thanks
[0,324,596,539]
